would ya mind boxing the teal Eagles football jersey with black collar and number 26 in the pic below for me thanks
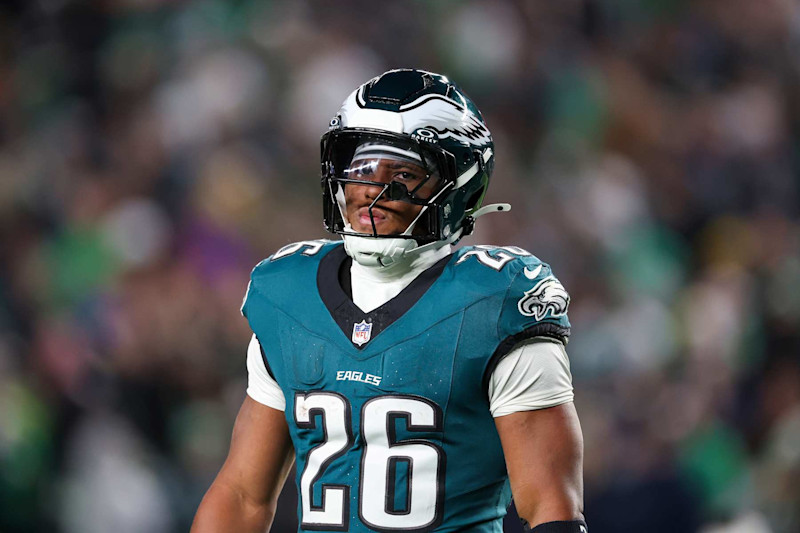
[242,241,569,532]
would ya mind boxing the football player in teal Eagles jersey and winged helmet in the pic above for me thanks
[192,70,587,533]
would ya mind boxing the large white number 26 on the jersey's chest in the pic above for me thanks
[294,392,445,531]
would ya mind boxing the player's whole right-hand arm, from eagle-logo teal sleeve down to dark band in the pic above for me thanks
[488,257,586,533]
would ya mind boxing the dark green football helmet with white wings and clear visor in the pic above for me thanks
[321,69,511,265]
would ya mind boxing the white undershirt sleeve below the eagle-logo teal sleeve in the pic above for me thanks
[489,339,574,418]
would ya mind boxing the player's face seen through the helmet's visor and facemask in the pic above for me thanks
[344,158,436,235]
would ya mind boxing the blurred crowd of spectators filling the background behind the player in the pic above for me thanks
[0,0,800,533]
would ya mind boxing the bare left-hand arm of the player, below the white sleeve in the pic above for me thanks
[191,396,294,533]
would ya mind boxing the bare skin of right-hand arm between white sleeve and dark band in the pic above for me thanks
[495,402,583,526]
